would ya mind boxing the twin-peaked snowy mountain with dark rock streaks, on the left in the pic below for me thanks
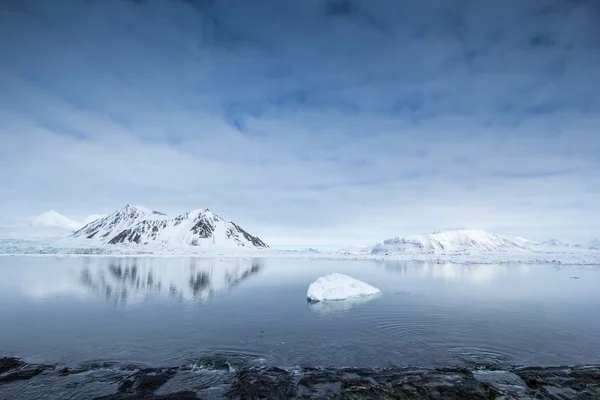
[73,205,269,249]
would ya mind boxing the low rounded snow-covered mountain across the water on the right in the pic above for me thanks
[371,229,528,254]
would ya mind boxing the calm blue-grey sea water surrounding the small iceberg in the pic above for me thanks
[0,257,600,367]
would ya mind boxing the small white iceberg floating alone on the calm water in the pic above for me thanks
[306,273,381,302]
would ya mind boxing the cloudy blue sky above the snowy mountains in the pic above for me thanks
[0,0,600,246]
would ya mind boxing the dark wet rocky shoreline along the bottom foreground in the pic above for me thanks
[0,357,600,400]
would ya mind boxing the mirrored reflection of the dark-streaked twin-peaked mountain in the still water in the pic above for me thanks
[79,258,263,304]
